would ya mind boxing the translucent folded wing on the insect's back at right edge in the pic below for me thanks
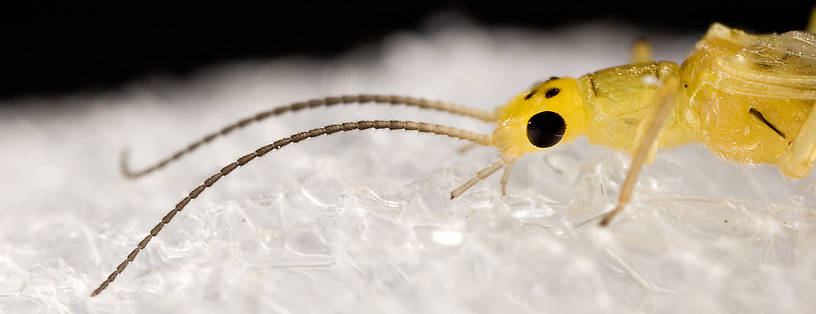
[707,25,816,99]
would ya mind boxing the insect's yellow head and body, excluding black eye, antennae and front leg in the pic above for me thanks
[493,24,816,177]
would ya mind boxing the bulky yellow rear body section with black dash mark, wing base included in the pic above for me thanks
[680,24,816,164]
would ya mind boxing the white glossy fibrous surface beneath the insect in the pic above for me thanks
[0,16,816,313]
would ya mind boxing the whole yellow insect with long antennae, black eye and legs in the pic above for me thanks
[91,24,816,296]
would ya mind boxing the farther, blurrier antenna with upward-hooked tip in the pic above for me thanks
[119,94,496,179]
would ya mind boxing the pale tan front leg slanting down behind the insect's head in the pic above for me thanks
[601,76,680,227]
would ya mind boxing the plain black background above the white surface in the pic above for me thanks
[0,0,813,103]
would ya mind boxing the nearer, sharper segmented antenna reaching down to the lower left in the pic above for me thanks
[91,120,492,297]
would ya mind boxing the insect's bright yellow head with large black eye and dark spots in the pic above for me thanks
[493,78,586,159]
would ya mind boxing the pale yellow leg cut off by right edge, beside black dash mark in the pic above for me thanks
[778,105,816,178]
